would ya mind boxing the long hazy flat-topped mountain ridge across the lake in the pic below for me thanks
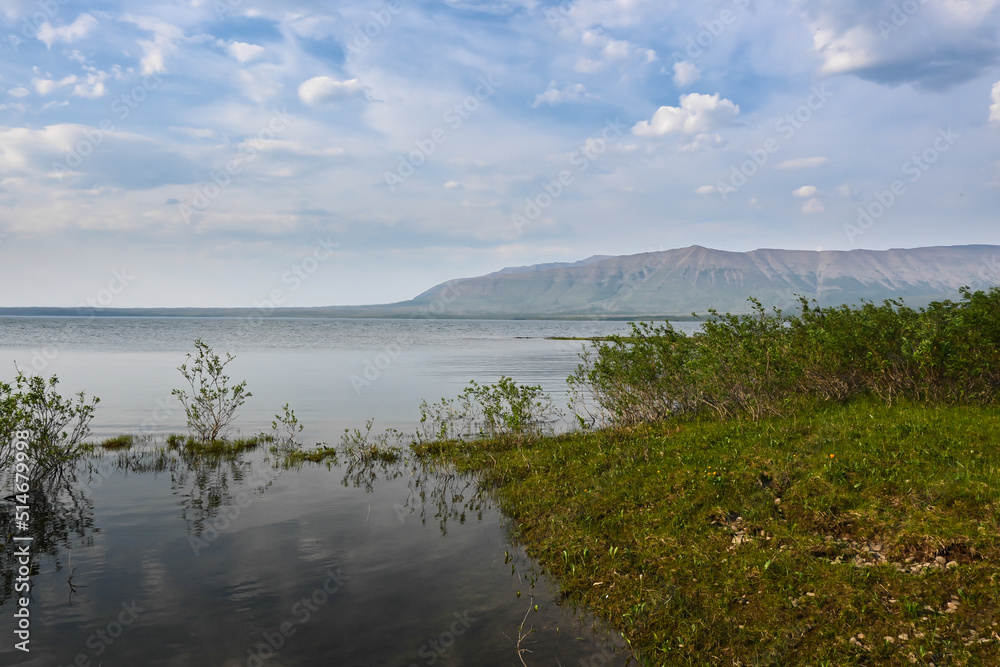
[406,245,1000,318]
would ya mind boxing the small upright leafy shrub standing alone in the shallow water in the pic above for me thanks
[171,338,252,442]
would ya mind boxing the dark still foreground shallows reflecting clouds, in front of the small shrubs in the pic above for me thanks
[0,442,627,667]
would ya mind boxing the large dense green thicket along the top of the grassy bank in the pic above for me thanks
[568,288,1000,426]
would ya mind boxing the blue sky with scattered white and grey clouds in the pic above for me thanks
[0,0,1000,309]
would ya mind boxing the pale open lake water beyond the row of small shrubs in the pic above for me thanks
[0,318,696,442]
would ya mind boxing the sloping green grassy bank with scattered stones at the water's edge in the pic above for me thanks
[417,400,1000,666]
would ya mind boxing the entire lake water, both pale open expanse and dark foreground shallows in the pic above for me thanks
[0,319,696,667]
